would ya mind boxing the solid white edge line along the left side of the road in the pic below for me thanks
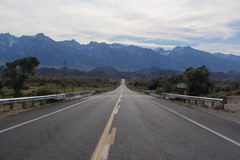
[0,96,99,134]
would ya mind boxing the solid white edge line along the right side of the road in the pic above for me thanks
[144,97,240,147]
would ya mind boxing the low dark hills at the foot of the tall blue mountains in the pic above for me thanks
[0,66,240,81]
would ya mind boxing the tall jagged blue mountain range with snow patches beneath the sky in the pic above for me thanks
[0,33,240,72]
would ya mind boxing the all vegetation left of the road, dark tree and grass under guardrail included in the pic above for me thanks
[0,57,120,117]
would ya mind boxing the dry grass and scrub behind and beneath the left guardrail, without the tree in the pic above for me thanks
[0,75,120,117]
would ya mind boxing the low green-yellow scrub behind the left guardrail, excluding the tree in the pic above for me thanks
[0,75,120,98]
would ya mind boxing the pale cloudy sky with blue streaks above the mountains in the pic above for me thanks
[0,0,240,55]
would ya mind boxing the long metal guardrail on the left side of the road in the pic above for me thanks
[0,90,95,105]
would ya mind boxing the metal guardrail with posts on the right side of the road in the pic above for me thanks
[150,92,224,109]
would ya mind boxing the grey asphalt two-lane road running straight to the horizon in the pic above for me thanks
[0,81,240,160]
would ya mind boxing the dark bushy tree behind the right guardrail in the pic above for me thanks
[184,65,211,96]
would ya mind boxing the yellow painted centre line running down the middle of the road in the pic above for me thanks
[91,88,123,160]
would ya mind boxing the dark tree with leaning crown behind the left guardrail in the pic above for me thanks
[3,57,39,97]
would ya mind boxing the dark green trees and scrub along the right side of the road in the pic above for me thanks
[127,66,240,110]
